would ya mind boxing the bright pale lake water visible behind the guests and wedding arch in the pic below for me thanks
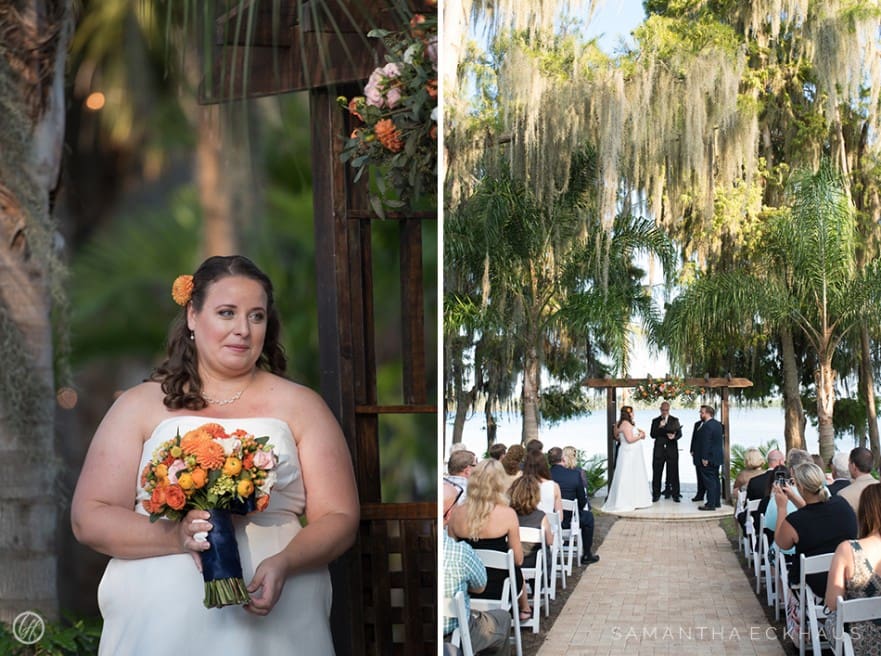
[444,406,868,483]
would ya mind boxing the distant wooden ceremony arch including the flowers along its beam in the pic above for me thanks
[583,375,753,501]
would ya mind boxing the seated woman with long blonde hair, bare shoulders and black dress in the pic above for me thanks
[447,458,532,620]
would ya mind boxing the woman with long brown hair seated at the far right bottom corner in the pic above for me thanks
[826,485,881,654]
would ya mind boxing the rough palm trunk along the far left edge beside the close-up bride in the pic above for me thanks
[0,0,73,621]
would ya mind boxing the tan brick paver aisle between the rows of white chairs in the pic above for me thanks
[538,519,784,656]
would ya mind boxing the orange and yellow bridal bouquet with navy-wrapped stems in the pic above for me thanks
[141,423,278,608]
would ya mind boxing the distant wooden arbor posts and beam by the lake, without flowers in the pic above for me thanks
[584,377,753,501]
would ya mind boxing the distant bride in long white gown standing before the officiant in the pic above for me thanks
[602,405,652,512]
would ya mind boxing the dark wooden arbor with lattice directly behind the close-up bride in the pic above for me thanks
[203,0,437,656]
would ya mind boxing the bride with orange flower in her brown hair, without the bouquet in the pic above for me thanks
[71,256,358,656]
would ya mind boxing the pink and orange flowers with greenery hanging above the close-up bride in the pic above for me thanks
[337,14,438,217]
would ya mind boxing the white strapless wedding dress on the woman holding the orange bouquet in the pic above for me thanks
[98,416,333,656]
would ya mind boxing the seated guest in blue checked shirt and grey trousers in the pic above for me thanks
[443,484,511,656]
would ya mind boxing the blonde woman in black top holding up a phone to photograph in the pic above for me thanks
[774,462,857,597]
